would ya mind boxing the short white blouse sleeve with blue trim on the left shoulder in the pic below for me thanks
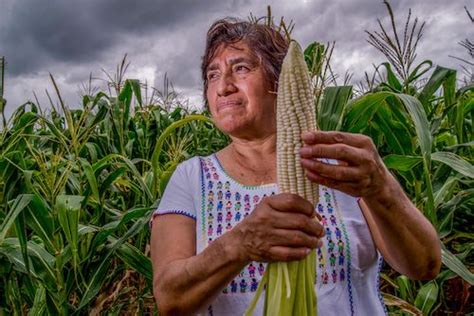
[150,163,196,226]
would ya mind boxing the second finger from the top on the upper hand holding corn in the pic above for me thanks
[300,144,364,165]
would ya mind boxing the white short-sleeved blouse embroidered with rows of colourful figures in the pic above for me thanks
[153,154,387,316]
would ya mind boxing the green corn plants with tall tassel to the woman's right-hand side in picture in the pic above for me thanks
[306,2,474,315]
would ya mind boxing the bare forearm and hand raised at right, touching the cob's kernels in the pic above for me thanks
[300,131,441,279]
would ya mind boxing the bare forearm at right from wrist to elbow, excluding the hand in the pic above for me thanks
[359,178,441,280]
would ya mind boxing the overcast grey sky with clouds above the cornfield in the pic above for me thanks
[0,0,474,118]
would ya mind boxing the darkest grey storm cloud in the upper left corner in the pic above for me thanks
[0,0,230,76]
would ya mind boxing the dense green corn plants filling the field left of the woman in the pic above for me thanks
[0,64,227,315]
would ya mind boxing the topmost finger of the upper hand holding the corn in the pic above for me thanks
[301,131,373,148]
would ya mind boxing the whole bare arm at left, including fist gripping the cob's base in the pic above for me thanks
[151,194,324,315]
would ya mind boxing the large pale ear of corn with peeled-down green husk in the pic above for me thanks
[246,41,319,316]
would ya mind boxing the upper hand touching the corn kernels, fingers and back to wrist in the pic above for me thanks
[300,131,391,198]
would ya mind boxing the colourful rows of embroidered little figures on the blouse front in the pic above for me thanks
[201,157,352,296]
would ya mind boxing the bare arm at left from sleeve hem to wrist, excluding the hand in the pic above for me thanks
[151,214,247,315]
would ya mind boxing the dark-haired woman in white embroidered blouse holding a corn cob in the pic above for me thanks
[151,19,441,315]
